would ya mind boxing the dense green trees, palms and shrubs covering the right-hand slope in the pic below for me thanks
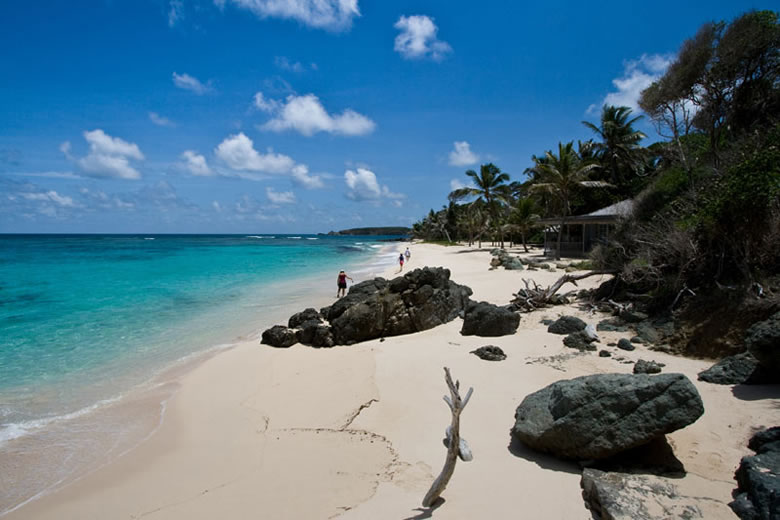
[413,11,780,306]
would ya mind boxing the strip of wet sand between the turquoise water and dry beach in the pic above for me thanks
[0,240,402,517]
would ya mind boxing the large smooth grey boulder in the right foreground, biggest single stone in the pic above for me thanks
[512,374,704,460]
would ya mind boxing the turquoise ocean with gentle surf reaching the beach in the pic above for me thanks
[0,235,396,515]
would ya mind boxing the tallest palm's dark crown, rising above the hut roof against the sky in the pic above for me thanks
[582,105,647,191]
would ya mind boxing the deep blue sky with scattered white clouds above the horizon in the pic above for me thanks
[0,0,771,233]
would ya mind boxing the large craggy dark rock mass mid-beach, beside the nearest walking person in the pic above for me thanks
[323,267,471,345]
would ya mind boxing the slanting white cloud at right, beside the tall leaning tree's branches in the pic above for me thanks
[587,54,673,114]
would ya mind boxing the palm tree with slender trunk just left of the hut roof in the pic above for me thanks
[532,141,609,260]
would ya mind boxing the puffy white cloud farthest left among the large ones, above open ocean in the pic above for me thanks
[74,128,144,179]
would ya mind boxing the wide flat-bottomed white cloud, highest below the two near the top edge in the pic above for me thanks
[255,92,376,136]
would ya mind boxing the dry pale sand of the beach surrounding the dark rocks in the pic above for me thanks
[7,245,780,519]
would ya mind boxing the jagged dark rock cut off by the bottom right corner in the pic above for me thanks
[729,427,780,520]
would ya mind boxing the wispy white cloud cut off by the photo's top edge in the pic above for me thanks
[219,0,360,31]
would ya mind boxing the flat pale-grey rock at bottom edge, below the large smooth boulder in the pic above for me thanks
[580,468,713,520]
